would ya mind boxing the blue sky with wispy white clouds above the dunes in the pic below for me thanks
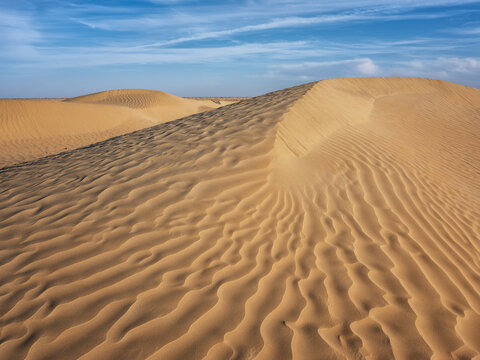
[0,0,480,98]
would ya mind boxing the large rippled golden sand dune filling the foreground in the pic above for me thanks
[0,78,480,360]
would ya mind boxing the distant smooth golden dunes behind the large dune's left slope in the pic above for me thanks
[0,89,231,167]
